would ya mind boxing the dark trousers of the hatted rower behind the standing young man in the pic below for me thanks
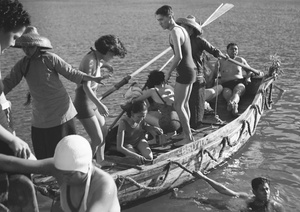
[189,78,205,129]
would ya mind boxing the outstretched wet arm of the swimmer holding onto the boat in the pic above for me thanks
[193,171,249,198]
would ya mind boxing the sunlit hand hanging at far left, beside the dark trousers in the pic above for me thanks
[9,136,31,159]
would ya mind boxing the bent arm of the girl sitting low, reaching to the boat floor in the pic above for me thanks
[117,120,144,162]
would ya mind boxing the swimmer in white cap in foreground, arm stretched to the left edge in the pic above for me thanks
[0,135,120,212]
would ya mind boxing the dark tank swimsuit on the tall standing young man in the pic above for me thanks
[170,26,197,84]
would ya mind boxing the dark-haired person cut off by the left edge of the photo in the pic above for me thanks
[0,0,39,212]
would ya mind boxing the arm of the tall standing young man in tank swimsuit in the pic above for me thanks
[165,27,183,82]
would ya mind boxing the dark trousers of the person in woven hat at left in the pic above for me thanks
[31,118,76,159]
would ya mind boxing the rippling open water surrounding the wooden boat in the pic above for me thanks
[1,0,300,212]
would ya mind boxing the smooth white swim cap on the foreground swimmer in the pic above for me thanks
[54,135,93,173]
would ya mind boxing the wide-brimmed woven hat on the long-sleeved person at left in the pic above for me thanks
[14,26,52,49]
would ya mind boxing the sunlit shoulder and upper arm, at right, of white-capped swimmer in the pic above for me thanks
[87,170,120,212]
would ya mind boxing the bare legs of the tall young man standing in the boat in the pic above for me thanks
[174,83,193,145]
